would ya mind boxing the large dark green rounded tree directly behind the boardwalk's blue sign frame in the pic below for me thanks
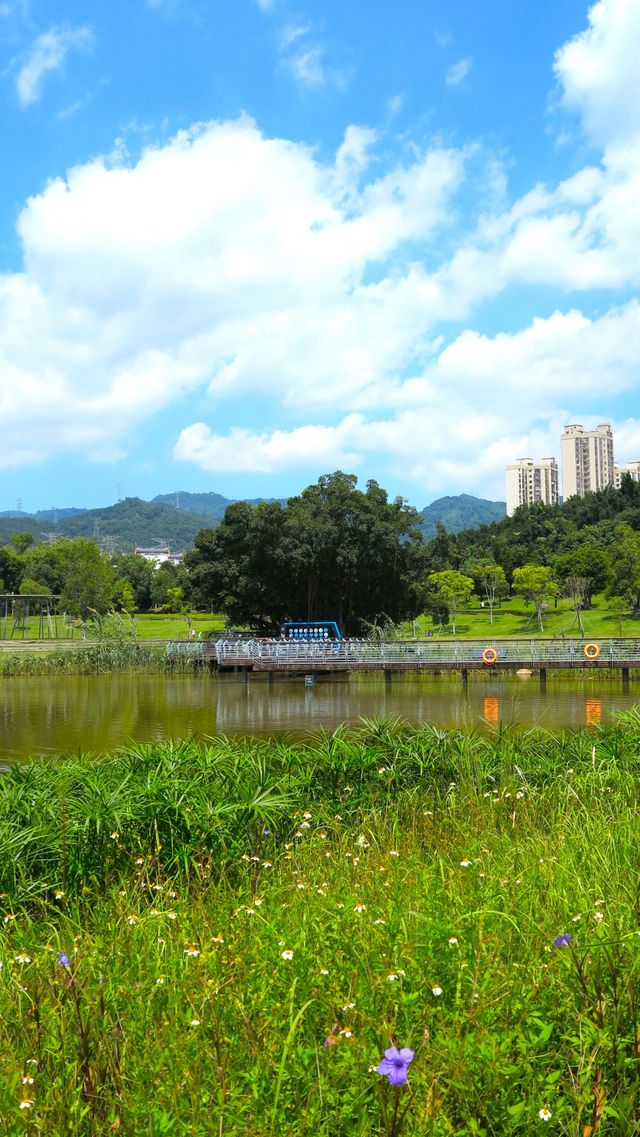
[186,471,422,634]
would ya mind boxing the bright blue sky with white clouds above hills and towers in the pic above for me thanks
[0,0,640,511]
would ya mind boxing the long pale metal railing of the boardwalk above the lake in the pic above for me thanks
[210,639,640,671]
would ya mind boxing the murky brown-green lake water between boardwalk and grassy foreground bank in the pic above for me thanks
[0,672,640,766]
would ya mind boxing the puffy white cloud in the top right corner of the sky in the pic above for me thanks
[555,0,640,146]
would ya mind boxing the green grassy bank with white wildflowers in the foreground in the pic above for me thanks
[0,723,640,1137]
